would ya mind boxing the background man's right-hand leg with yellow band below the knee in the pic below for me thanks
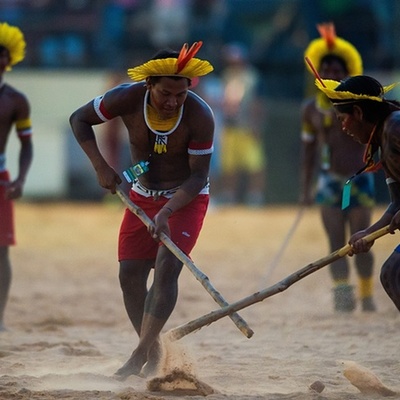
[349,206,376,312]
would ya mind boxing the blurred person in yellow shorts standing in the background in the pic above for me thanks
[219,43,267,206]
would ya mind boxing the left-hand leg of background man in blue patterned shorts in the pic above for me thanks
[321,206,355,312]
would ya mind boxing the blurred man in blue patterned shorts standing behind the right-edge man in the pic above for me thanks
[300,23,376,312]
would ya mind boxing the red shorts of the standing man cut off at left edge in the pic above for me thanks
[0,171,15,247]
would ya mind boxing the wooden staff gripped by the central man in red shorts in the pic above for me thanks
[116,187,254,338]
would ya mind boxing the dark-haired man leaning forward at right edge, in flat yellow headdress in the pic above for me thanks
[316,75,400,311]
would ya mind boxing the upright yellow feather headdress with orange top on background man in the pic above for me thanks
[304,22,363,76]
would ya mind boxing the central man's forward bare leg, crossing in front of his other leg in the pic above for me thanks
[116,246,182,378]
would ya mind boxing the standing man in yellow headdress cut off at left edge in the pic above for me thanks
[0,22,33,331]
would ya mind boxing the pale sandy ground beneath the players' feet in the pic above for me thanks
[0,199,400,400]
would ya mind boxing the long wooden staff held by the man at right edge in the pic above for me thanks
[165,225,389,341]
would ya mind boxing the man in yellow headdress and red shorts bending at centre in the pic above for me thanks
[70,42,214,379]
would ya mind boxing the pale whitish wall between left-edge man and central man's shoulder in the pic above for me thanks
[4,70,107,197]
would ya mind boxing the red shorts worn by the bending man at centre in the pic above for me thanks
[118,190,209,261]
